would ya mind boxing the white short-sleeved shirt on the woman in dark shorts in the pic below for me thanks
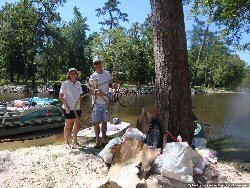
[60,80,83,110]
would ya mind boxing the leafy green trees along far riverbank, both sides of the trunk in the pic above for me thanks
[0,0,246,88]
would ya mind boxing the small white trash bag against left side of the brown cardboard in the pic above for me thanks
[98,138,122,164]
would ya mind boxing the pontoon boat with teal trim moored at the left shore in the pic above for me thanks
[0,97,64,138]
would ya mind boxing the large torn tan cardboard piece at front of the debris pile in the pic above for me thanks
[108,138,160,188]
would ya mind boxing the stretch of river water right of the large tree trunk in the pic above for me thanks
[192,93,250,138]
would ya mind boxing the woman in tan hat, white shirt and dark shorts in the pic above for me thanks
[59,68,83,146]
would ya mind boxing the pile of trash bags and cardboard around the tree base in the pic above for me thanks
[93,110,217,188]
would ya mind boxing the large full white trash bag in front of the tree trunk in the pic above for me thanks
[161,142,198,183]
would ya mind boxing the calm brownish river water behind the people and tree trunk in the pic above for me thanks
[0,93,250,149]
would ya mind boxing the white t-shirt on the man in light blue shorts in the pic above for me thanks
[90,70,112,104]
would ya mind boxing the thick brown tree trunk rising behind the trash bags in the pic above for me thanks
[151,0,194,143]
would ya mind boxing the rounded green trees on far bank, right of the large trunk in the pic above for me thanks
[189,24,245,88]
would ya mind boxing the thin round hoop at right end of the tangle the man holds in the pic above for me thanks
[118,88,137,107]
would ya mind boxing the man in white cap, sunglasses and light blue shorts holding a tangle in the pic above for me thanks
[90,57,112,148]
